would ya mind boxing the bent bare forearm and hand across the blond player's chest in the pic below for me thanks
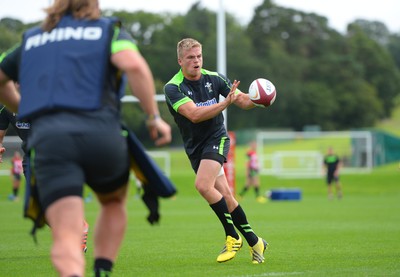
[178,80,240,123]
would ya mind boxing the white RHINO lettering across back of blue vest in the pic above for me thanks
[25,27,103,51]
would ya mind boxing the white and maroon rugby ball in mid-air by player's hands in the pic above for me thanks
[249,78,276,108]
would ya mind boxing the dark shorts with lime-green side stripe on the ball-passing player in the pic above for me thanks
[189,137,230,173]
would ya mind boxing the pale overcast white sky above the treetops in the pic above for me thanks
[0,0,400,33]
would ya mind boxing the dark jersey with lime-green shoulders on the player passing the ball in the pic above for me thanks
[164,69,232,156]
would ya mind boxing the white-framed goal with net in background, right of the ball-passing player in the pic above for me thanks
[257,131,373,178]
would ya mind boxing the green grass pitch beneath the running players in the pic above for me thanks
[0,151,400,276]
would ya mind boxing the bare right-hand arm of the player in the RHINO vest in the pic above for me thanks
[111,50,171,145]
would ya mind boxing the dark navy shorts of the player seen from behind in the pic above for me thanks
[31,130,129,209]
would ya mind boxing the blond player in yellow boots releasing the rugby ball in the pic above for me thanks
[164,38,268,264]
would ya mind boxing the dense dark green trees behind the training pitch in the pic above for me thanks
[0,0,400,144]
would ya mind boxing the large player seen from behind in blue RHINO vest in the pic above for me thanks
[0,0,171,276]
